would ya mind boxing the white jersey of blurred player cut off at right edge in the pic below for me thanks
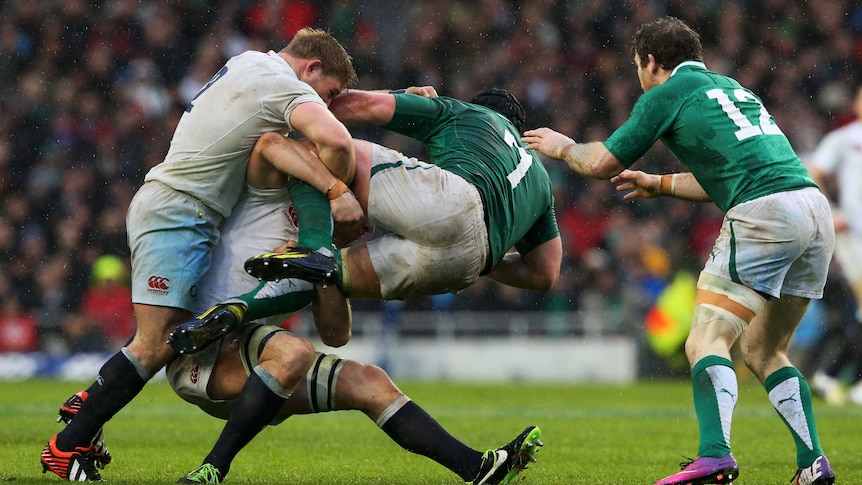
[811,120,862,235]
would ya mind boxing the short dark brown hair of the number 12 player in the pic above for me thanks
[630,16,703,70]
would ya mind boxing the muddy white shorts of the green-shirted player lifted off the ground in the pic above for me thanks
[368,145,489,299]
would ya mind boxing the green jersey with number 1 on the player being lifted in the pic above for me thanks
[384,94,560,271]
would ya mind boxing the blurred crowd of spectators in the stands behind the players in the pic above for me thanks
[0,0,862,353]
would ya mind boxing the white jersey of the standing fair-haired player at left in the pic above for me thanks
[145,51,326,217]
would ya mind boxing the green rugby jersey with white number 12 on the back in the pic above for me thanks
[605,61,817,212]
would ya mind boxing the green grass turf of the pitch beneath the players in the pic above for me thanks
[0,380,862,485]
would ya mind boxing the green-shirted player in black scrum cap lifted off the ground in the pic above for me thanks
[246,85,562,300]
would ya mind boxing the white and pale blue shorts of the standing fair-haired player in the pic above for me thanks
[126,182,222,312]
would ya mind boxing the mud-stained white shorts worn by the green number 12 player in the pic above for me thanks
[703,188,835,298]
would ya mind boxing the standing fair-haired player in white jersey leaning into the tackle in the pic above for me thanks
[41,29,364,481]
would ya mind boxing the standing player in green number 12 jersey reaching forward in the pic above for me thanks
[522,17,835,485]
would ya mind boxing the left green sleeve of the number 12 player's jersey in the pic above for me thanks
[605,86,678,168]
